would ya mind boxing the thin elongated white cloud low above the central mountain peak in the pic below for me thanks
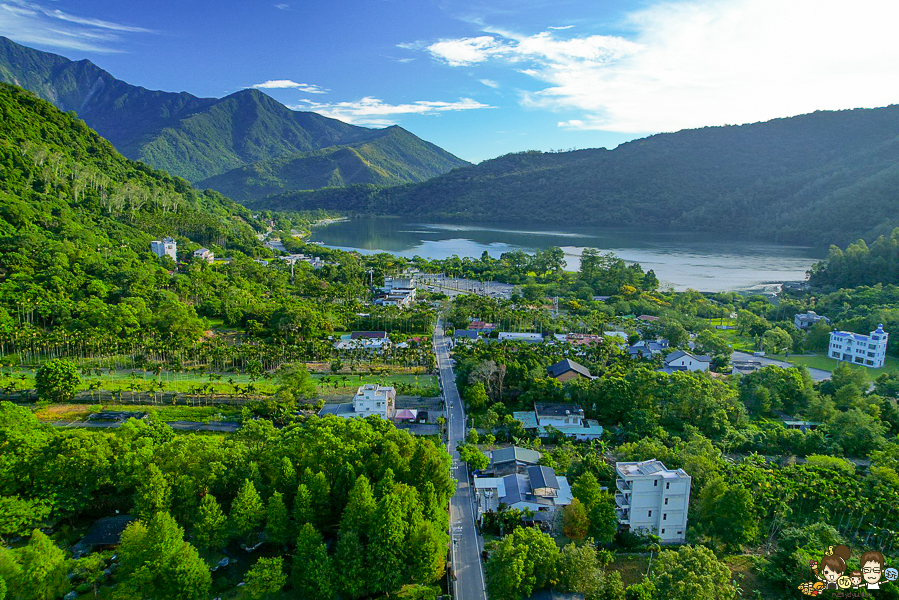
[290,96,493,126]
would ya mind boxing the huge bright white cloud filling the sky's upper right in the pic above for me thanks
[418,0,899,133]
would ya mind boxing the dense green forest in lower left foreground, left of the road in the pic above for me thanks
[0,402,453,600]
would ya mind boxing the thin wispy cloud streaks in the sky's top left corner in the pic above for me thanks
[0,0,154,53]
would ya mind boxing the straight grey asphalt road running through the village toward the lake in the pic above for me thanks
[434,321,487,600]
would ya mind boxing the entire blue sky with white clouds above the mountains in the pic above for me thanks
[0,0,899,162]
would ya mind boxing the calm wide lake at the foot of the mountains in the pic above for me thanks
[310,217,824,293]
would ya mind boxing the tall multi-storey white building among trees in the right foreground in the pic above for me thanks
[615,459,691,543]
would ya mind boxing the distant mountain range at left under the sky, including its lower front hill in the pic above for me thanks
[0,37,468,199]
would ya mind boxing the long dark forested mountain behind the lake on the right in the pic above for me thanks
[266,106,899,245]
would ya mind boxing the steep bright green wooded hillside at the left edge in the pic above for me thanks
[0,84,266,339]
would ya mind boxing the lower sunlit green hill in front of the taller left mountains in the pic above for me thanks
[197,126,466,202]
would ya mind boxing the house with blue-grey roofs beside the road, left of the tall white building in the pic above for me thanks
[474,465,573,520]
